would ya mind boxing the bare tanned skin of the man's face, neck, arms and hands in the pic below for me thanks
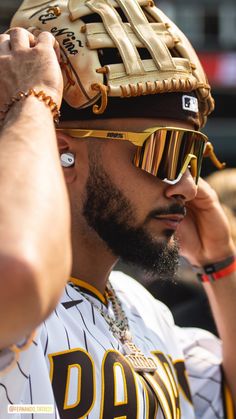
[0,30,236,410]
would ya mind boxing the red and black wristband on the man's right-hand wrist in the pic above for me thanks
[193,255,236,283]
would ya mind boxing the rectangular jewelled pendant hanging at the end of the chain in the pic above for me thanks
[123,342,157,373]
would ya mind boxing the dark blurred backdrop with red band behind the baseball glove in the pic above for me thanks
[0,0,236,175]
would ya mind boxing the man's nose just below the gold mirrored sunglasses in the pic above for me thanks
[165,169,197,202]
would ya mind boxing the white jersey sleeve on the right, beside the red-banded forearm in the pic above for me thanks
[176,326,234,419]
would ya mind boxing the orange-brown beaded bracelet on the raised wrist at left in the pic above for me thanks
[0,89,60,124]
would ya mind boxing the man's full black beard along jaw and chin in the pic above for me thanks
[83,149,180,278]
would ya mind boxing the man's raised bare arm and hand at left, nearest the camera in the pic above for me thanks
[0,29,71,348]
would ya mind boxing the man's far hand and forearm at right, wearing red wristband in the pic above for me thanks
[179,180,236,407]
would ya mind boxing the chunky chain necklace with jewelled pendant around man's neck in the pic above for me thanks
[69,281,157,373]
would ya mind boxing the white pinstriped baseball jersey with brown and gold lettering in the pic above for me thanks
[0,272,233,419]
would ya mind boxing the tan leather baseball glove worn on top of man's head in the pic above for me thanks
[11,0,214,125]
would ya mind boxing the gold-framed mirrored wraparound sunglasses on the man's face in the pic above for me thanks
[57,127,225,184]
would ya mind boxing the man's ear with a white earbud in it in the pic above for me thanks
[57,132,76,183]
